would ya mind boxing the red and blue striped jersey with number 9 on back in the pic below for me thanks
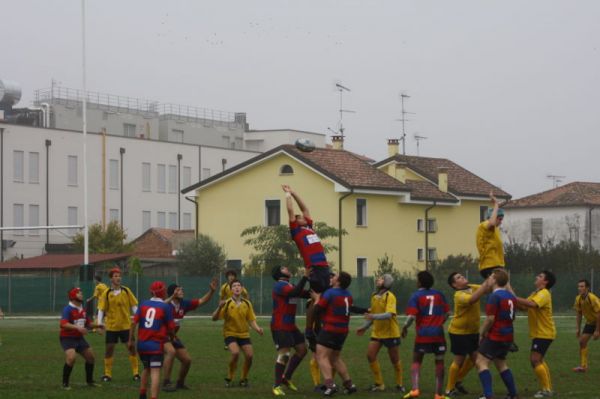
[133,298,175,355]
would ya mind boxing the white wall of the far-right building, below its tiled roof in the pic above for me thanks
[503,207,600,249]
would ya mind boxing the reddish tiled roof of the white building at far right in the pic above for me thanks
[506,182,600,209]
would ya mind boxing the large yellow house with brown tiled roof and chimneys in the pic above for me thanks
[183,137,510,276]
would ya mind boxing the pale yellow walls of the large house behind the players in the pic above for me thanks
[198,154,487,274]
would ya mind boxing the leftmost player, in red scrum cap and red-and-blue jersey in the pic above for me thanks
[60,288,101,390]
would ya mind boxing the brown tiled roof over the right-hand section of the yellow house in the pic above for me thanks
[375,154,510,198]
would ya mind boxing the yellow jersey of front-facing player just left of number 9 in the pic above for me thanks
[98,285,138,331]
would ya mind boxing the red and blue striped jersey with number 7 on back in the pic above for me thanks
[406,288,450,344]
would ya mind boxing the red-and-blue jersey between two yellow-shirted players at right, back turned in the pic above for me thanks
[485,288,517,342]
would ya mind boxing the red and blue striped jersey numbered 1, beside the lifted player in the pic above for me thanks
[317,288,352,334]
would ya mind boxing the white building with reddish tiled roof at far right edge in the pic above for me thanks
[503,182,600,250]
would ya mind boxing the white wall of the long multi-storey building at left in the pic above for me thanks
[0,124,256,259]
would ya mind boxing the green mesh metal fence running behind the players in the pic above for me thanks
[0,270,594,315]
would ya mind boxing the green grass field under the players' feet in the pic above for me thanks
[0,317,600,399]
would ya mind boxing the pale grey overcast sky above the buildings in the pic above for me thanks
[0,0,600,198]
